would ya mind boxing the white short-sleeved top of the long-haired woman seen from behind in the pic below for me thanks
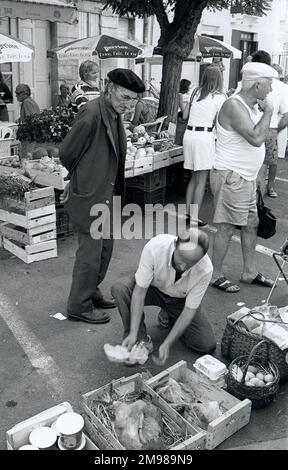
[188,88,226,127]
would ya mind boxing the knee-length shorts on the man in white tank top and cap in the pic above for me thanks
[210,169,258,227]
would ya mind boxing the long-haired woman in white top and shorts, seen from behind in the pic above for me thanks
[183,66,226,227]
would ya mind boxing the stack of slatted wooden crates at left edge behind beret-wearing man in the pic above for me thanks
[0,186,57,264]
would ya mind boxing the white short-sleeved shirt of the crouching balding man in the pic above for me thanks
[135,234,213,309]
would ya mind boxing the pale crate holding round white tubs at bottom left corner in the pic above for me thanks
[6,402,99,450]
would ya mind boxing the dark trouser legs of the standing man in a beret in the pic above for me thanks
[67,232,113,314]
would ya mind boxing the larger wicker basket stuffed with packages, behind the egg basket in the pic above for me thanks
[221,312,288,382]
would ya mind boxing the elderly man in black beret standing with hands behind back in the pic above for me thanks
[59,68,145,323]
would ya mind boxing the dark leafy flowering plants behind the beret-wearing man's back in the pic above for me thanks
[16,108,75,143]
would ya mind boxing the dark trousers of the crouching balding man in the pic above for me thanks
[111,276,216,353]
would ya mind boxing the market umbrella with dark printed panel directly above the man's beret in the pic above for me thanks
[47,34,148,60]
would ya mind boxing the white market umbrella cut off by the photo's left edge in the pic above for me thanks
[0,33,34,64]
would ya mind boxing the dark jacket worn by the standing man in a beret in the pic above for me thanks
[59,95,126,232]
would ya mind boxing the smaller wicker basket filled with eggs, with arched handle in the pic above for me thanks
[226,340,280,409]
